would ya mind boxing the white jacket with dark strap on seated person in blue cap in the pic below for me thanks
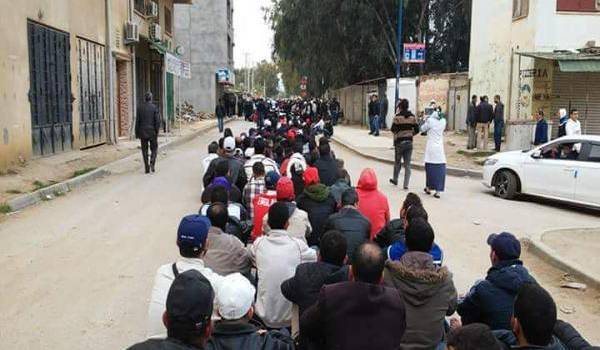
[147,258,223,338]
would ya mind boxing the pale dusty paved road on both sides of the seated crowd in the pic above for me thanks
[0,122,600,349]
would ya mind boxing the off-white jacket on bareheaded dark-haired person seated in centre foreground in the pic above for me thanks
[248,230,317,328]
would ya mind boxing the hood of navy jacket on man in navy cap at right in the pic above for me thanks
[486,260,535,294]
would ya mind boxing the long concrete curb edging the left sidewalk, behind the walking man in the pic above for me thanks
[6,118,231,212]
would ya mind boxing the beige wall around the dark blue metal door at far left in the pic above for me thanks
[0,0,105,170]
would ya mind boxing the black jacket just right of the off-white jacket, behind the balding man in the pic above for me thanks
[281,261,350,316]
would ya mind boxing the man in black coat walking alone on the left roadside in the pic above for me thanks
[135,92,160,174]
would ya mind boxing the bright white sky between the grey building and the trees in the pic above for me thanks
[233,0,273,68]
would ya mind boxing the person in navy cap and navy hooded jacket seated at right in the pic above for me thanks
[457,232,535,330]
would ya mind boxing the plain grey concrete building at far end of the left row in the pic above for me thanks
[175,0,235,113]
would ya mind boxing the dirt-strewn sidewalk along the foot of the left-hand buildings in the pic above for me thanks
[0,119,220,205]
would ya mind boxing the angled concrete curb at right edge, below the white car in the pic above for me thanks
[521,228,600,290]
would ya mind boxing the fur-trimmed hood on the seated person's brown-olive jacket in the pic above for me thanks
[386,252,452,306]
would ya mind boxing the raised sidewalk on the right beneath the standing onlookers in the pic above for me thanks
[333,125,491,172]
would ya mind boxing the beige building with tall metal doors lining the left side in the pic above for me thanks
[0,0,191,171]
